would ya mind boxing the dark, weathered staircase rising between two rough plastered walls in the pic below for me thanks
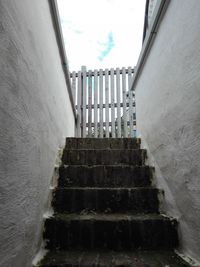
[39,138,188,267]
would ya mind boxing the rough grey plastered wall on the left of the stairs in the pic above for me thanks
[0,0,74,267]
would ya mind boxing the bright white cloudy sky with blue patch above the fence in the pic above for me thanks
[58,0,146,71]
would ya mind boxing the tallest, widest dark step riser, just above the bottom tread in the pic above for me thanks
[44,214,178,250]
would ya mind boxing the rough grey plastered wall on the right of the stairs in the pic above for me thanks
[136,0,200,266]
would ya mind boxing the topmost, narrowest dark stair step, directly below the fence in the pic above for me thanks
[65,138,141,149]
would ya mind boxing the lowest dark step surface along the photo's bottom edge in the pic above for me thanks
[39,251,189,267]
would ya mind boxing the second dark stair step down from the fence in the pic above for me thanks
[62,149,146,166]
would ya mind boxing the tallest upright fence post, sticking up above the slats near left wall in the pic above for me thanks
[81,66,87,138]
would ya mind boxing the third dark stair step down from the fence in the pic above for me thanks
[58,165,153,187]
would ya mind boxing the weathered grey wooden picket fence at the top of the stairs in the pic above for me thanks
[70,67,136,138]
